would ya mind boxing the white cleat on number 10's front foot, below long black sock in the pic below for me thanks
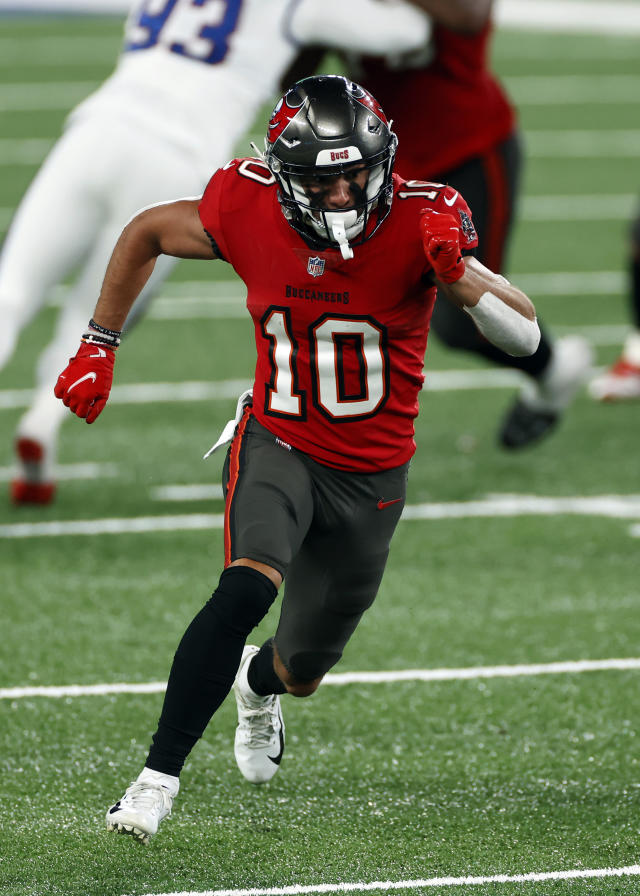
[107,768,180,844]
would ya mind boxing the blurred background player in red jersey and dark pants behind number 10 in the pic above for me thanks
[285,0,592,449]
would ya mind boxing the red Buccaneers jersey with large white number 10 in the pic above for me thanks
[199,159,477,472]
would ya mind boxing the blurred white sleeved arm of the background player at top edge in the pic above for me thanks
[289,0,431,55]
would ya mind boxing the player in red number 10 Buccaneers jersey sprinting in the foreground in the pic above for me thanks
[56,76,540,842]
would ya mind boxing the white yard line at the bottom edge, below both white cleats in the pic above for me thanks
[124,865,640,896]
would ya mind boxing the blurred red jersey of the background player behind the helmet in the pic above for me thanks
[358,22,515,177]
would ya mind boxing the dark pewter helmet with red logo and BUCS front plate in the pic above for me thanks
[265,75,398,258]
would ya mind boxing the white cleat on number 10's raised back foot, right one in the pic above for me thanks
[233,645,284,784]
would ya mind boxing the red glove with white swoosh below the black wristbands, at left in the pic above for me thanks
[53,342,116,423]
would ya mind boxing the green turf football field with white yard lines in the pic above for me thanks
[0,17,640,896]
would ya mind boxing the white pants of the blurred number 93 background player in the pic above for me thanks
[0,118,200,478]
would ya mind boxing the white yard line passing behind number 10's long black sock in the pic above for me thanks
[0,657,640,700]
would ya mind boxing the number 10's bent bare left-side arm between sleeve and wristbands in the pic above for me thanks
[93,199,217,330]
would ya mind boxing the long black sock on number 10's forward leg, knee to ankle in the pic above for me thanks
[145,566,277,776]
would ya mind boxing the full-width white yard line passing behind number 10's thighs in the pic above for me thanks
[0,494,640,538]
